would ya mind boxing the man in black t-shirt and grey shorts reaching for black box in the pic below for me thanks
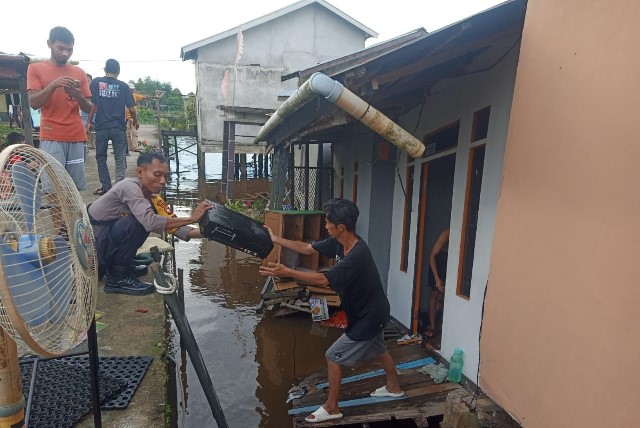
[260,199,404,422]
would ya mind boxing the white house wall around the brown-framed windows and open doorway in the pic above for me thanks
[388,44,518,381]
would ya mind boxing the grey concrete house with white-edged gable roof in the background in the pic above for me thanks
[181,0,377,157]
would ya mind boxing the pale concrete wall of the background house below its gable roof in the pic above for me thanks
[195,5,365,143]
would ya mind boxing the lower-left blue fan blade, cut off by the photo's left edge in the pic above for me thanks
[0,238,51,326]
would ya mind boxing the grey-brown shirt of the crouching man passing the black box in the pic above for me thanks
[89,177,193,241]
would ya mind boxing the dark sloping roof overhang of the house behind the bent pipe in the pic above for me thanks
[258,0,527,146]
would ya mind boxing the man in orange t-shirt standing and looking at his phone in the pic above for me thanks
[27,27,92,190]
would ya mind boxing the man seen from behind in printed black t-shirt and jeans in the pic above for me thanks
[87,59,139,195]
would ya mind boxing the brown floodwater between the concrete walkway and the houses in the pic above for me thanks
[167,140,342,428]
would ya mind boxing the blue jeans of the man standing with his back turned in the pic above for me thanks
[96,127,127,191]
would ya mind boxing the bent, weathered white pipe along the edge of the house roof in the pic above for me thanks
[255,73,424,158]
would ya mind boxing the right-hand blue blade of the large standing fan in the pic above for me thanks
[44,236,73,323]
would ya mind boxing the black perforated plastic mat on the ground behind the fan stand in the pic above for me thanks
[20,356,153,428]
